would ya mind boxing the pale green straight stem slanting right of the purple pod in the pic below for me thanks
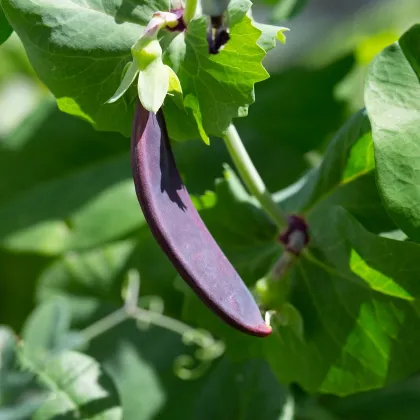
[223,124,287,229]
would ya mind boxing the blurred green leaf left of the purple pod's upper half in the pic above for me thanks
[0,154,143,255]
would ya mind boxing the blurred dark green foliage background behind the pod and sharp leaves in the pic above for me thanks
[0,0,420,420]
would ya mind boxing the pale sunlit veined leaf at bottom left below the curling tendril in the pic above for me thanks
[34,351,123,420]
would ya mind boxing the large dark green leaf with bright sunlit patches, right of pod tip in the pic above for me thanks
[264,207,420,395]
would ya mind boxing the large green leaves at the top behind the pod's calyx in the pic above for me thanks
[4,0,284,141]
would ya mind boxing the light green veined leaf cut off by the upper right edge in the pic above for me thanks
[365,25,420,240]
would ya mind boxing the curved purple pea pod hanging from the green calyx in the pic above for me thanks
[131,102,271,337]
